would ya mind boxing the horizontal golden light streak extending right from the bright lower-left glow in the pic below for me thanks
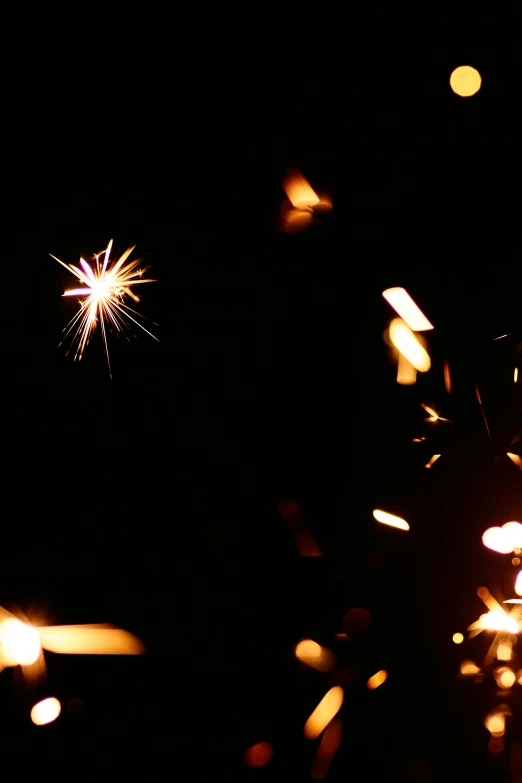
[37,623,145,655]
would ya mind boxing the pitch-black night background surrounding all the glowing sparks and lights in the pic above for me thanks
[0,4,522,781]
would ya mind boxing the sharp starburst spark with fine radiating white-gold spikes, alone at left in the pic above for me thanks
[53,239,159,378]
